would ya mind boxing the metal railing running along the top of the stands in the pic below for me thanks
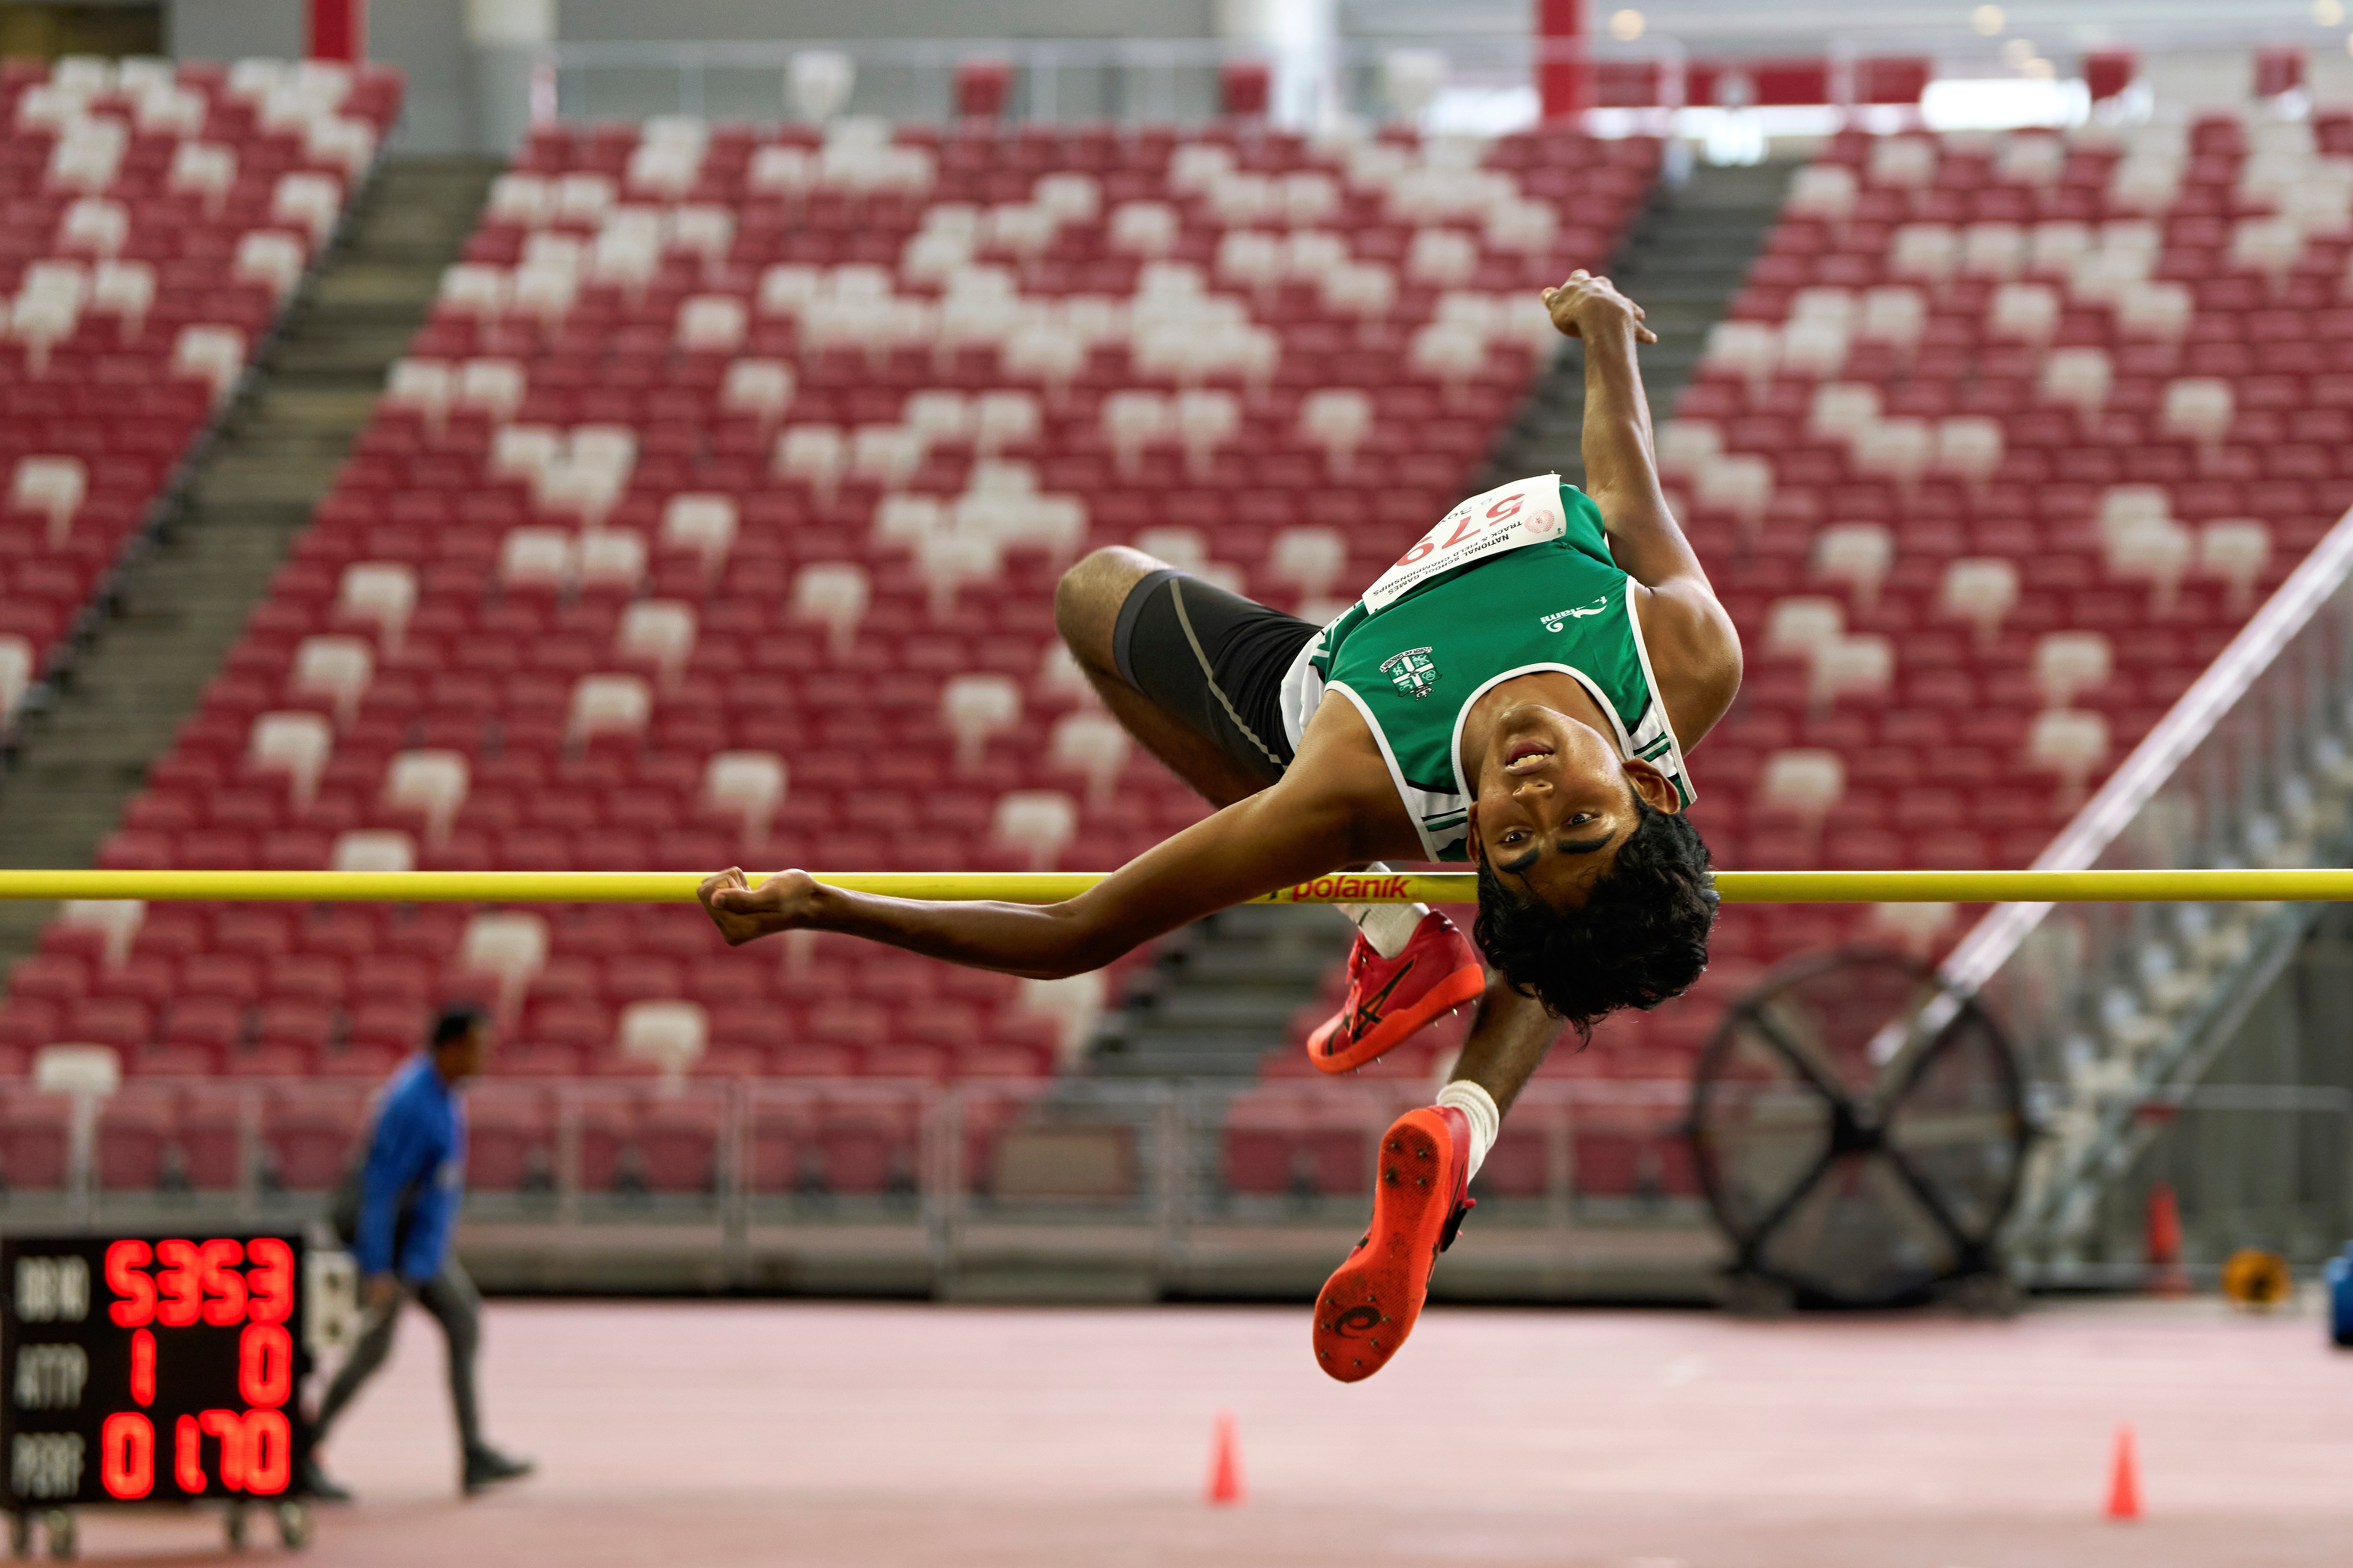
[532,31,2327,134]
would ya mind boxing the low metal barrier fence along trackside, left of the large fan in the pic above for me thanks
[0,1079,1718,1298]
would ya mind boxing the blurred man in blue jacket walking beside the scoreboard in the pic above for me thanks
[304,1008,532,1502]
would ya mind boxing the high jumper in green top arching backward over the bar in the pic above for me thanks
[704,270,1741,1382]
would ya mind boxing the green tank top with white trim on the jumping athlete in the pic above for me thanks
[1282,484,1694,860]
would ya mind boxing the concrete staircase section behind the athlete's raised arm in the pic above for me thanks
[1475,162,1798,489]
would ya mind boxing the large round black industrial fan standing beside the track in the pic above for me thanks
[1690,952,2028,1309]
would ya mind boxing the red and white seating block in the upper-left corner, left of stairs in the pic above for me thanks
[0,61,400,731]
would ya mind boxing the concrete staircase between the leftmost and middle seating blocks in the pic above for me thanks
[0,158,499,964]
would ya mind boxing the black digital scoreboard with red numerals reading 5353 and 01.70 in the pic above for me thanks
[0,1234,311,1509]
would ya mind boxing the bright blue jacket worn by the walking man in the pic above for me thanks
[351,1053,466,1283]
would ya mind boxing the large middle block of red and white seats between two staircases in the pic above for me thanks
[0,120,1659,1114]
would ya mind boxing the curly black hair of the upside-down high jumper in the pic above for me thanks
[1471,790,1715,1039]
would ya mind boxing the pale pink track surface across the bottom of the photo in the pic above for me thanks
[55,1302,2353,1568]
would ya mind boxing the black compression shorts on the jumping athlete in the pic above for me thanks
[1110,569,1320,783]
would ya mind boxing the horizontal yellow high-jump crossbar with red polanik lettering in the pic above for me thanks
[0,870,2353,903]
